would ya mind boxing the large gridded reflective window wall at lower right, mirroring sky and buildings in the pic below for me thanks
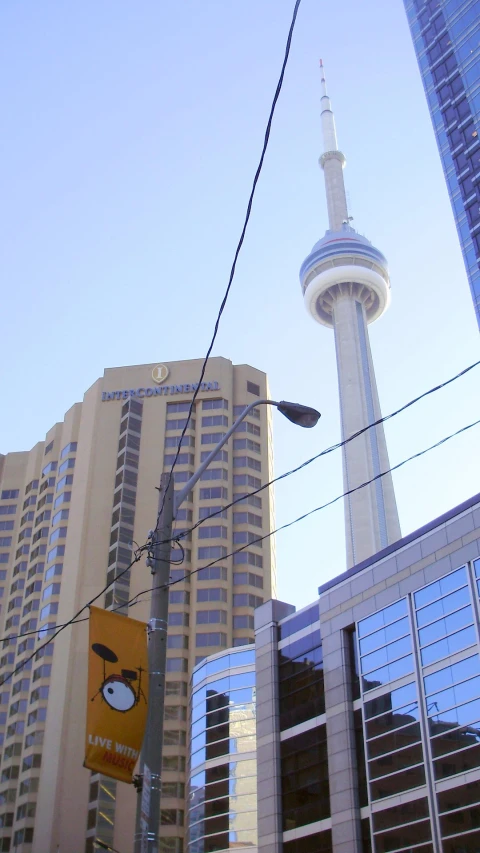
[356,559,480,853]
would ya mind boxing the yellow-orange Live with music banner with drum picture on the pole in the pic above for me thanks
[84,607,148,782]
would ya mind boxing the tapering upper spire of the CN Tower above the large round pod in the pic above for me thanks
[319,59,349,231]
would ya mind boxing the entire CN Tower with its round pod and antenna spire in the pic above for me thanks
[300,60,401,567]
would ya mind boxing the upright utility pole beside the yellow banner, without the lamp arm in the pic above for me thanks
[135,473,174,853]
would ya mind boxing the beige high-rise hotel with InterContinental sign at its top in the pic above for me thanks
[0,358,275,853]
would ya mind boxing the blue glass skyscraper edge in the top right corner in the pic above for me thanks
[404,0,480,326]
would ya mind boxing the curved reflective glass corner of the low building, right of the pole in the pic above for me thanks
[187,647,257,853]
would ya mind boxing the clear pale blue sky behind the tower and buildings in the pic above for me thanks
[0,0,480,606]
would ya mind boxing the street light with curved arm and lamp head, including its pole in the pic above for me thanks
[135,399,320,853]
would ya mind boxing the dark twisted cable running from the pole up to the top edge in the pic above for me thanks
[155,0,301,532]
